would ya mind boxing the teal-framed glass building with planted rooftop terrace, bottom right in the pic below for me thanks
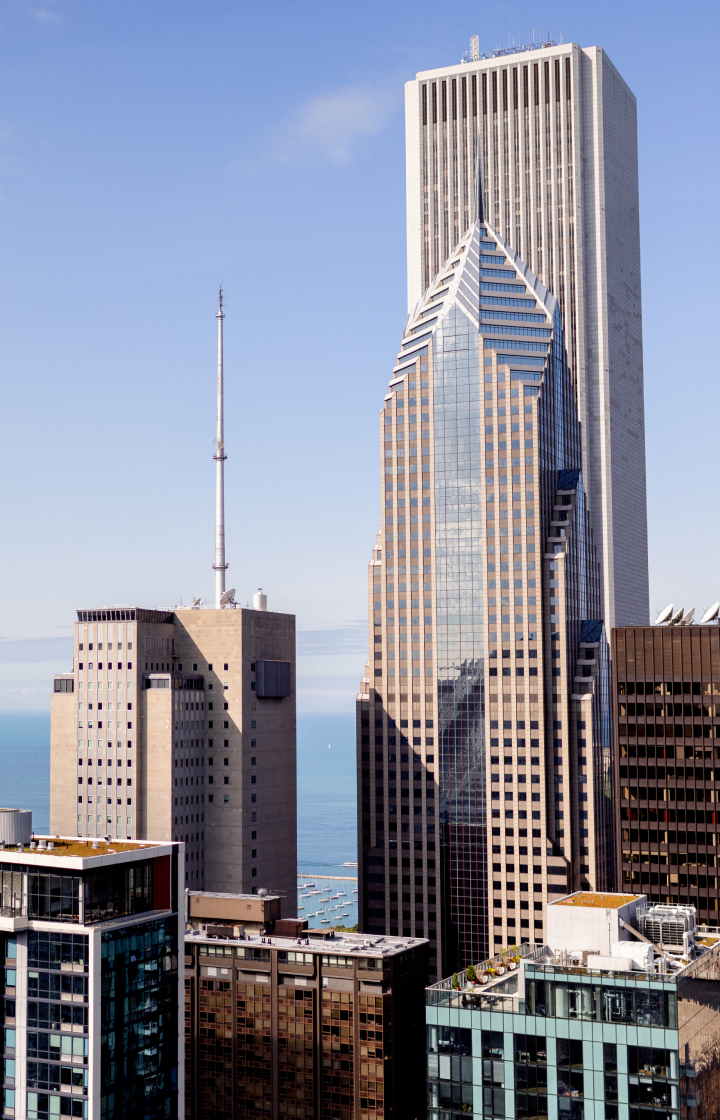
[426,926,720,1120]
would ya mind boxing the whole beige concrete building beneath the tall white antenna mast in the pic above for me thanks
[50,596,297,912]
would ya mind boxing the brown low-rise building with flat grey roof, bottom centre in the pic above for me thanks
[185,895,428,1120]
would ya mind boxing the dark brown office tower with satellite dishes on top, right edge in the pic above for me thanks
[613,616,720,925]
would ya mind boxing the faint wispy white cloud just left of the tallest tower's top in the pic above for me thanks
[244,82,402,167]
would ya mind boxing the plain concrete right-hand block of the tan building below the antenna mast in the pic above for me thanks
[176,609,297,916]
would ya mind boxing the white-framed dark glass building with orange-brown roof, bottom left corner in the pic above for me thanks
[0,810,185,1120]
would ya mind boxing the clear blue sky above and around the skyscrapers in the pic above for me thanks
[0,0,720,710]
